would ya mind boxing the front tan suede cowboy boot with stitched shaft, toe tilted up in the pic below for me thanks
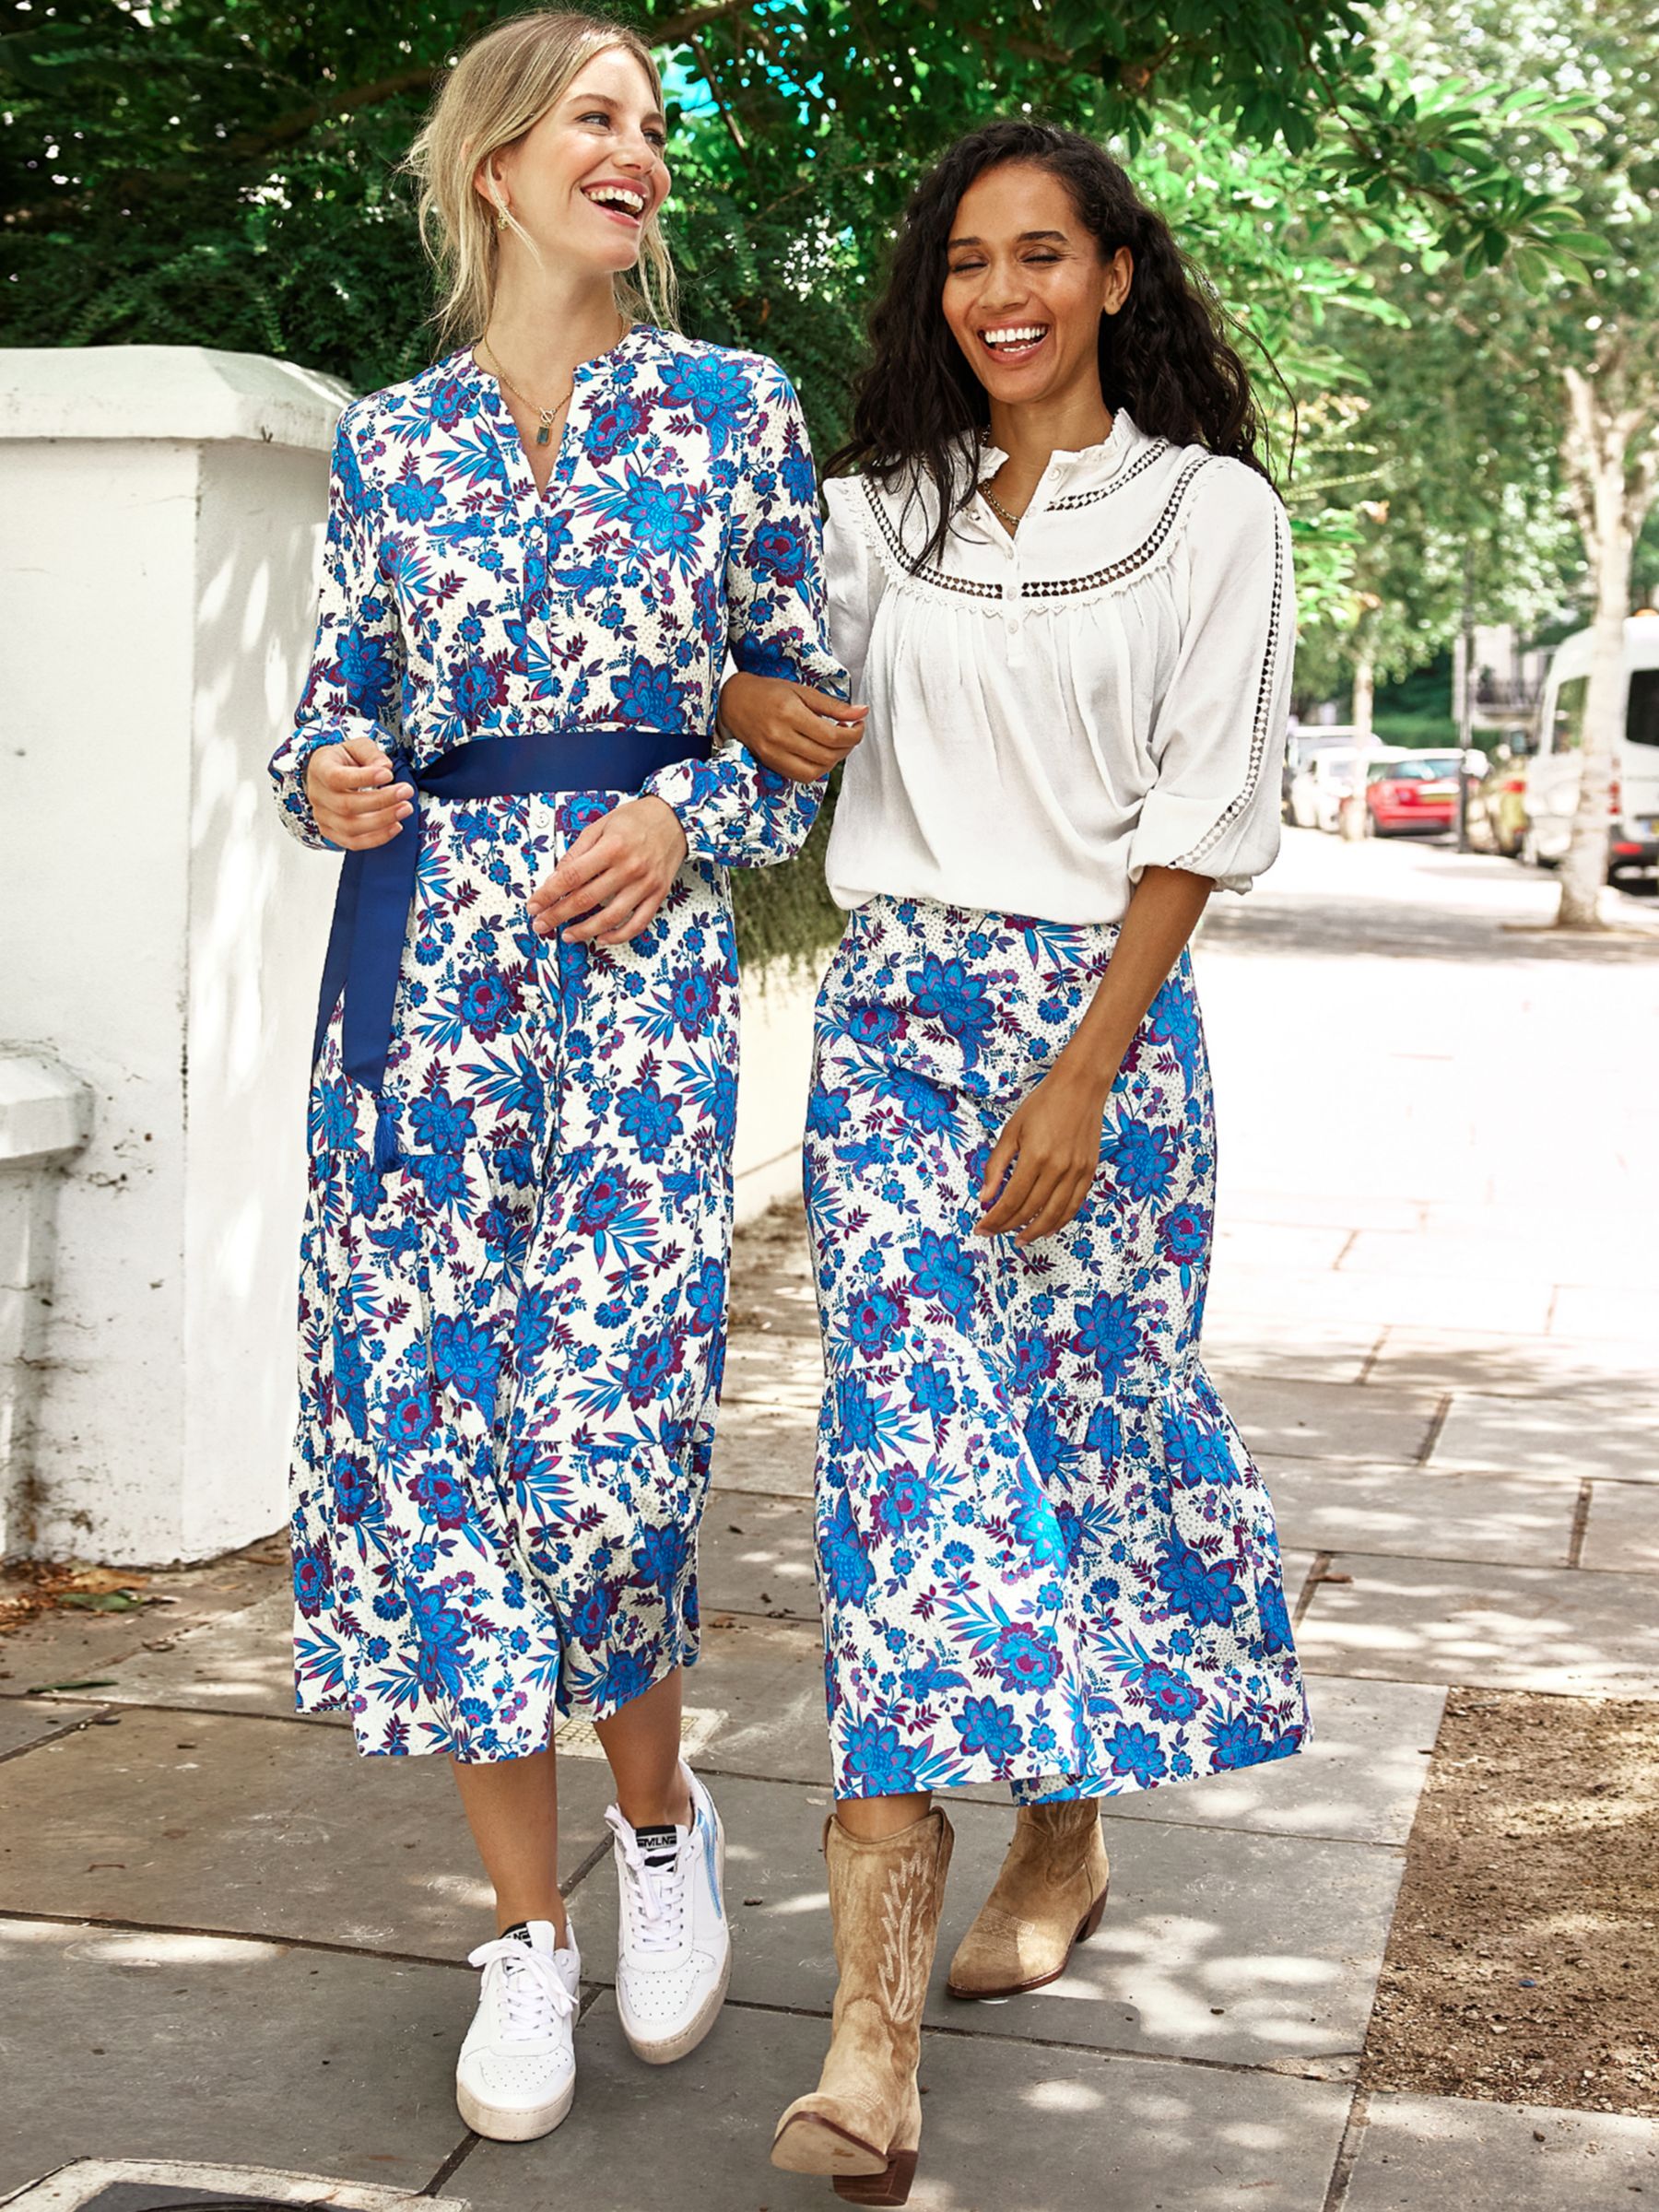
[772,1807,953,2206]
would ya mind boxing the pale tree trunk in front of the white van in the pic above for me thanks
[1555,359,1654,929]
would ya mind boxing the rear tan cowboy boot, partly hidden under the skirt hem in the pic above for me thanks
[949,1798,1111,1997]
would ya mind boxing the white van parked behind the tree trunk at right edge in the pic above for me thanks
[1520,608,1659,876]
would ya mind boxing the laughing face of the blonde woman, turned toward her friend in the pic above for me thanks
[477,46,668,275]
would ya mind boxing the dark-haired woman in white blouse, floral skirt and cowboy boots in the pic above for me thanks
[724,124,1307,2203]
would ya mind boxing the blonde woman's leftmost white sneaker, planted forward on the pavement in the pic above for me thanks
[455,1920,582,2144]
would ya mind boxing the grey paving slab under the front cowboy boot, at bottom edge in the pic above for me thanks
[447,1995,1349,2212]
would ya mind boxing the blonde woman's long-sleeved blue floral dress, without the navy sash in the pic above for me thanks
[272,327,845,1760]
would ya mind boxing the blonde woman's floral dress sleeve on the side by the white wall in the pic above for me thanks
[270,409,403,852]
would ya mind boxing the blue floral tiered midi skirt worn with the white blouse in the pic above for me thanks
[806,898,1307,1801]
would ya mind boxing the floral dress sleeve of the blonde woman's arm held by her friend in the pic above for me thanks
[646,360,847,867]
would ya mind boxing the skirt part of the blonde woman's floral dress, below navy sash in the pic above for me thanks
[292,794,736,1760]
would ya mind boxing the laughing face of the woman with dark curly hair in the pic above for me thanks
[942,161,1135,407]
